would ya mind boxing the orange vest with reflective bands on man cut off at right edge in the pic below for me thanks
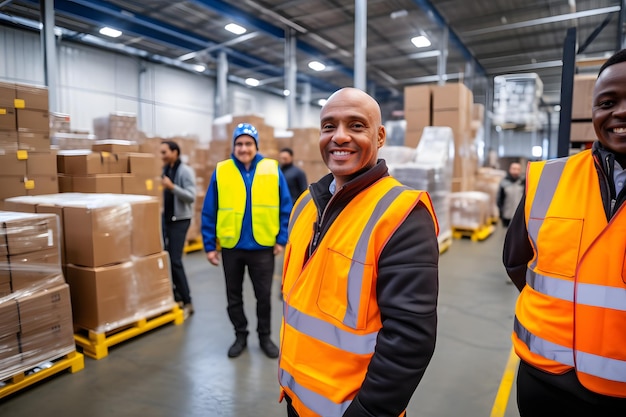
[513,150,626,397]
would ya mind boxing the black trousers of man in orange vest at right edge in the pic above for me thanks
[517,361,626,417]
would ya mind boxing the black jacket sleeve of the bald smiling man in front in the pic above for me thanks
[344,204,439,417]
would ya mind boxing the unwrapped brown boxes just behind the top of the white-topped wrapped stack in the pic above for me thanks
[57,140,161,197]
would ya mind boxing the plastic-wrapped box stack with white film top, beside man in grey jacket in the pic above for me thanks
[5,193,174,333]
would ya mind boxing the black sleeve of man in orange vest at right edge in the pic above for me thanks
[502,195,534,291]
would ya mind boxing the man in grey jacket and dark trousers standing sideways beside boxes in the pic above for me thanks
[160,141,196,317]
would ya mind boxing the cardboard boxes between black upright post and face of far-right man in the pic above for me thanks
[570,74,597,142]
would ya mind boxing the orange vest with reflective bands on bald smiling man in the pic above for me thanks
[279,177,438,417]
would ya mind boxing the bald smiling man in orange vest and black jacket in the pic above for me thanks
[279,88,439,417]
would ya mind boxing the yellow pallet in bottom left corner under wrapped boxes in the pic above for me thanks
[0,351,85,398]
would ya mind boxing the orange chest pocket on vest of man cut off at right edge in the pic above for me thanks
[528,217,583,278]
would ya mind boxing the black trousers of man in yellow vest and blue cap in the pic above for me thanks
[222,248,274,336]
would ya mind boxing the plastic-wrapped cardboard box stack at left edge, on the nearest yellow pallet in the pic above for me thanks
[0,211,75,381]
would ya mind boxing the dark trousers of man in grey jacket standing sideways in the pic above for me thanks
[163,219,191,304]
